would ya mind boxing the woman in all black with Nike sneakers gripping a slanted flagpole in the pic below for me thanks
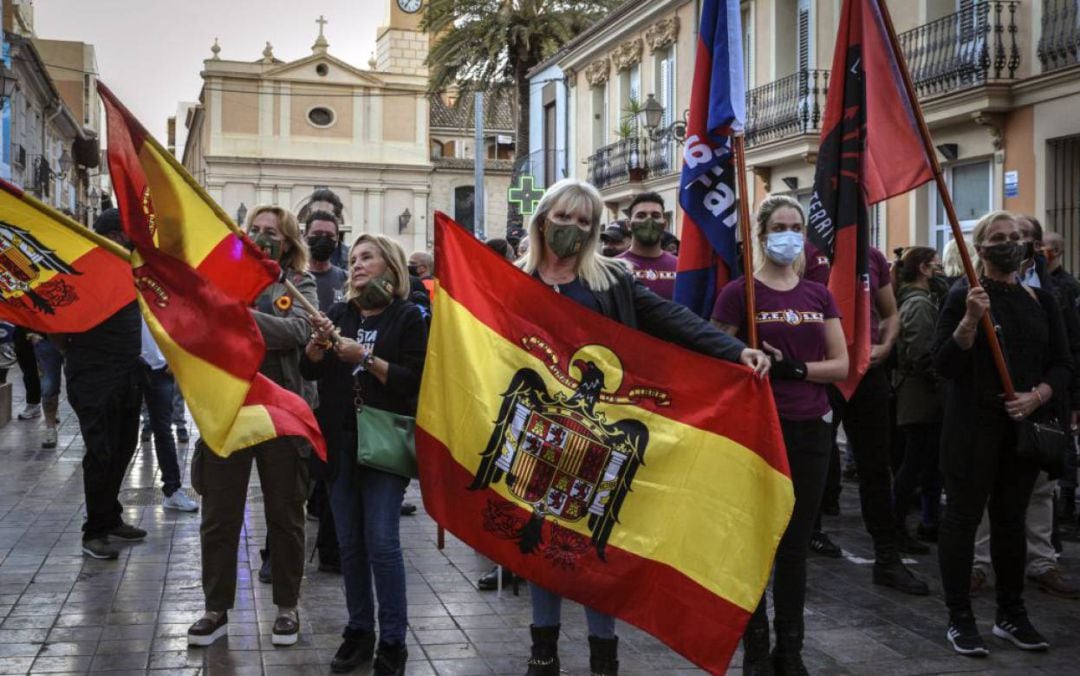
[933,212,1070,657]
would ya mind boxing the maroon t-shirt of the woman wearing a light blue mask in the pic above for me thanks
[713,278,840,420]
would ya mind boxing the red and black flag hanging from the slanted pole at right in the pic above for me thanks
[809,0,933,396]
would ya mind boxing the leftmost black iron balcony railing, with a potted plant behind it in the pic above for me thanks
[589,125,679,188]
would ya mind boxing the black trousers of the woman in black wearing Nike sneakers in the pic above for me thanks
[937,413,1039,617]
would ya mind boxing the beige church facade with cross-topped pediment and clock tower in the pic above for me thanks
[176,1,509,252]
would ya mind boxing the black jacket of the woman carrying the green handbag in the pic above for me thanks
[300,299,428,477]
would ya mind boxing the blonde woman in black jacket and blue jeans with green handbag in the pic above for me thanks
[300,234,428,676]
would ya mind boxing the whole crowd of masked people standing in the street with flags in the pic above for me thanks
[15,179,1080,676]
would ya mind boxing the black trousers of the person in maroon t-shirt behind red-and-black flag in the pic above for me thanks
[829,367,900,564]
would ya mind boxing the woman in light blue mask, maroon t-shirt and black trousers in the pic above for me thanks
[713,195,848,674]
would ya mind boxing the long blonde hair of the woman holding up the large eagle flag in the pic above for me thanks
[514,178,629,292]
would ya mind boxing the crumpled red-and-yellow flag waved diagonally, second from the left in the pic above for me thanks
[98,83,326,459]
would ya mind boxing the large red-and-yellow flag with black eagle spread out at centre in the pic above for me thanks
[416,214,794,673]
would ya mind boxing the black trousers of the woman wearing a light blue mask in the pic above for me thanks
[751,418,833,631]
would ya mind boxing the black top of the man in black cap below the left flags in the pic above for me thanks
[64,300,143,386]
